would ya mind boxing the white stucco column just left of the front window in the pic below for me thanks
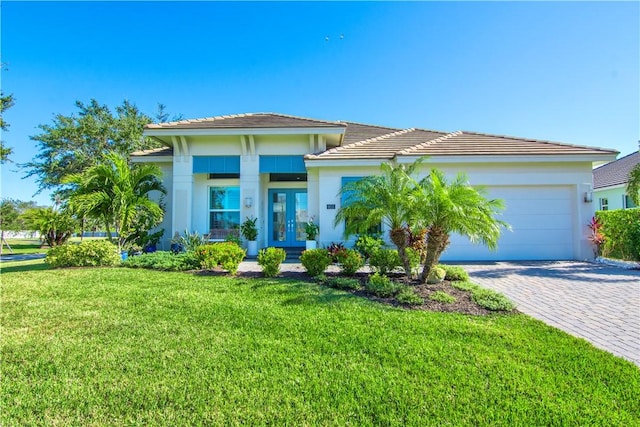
[171,156,193,237]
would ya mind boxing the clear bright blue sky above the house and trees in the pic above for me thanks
[0,1,640,204]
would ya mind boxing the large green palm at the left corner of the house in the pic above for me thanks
[63,152,166,250]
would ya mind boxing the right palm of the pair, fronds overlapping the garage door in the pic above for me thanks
[416,169,509,283]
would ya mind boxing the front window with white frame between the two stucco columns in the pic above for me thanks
[209,187,240,240]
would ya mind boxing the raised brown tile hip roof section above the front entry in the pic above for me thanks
[144,113,346,129]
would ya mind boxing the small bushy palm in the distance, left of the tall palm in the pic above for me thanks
[24,207,78,247]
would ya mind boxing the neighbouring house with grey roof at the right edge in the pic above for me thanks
[593,151,640,211]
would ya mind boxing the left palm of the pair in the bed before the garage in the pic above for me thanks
[334,159,422,274]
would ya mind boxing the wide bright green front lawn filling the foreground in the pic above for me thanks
[0,263,640,426]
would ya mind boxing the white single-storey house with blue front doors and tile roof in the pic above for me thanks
[132,113,617,260]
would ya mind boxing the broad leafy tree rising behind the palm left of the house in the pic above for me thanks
[21,99,171,190]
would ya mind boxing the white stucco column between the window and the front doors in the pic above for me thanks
[240,154,260,247]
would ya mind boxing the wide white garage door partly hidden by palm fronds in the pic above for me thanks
[442,186,575,261]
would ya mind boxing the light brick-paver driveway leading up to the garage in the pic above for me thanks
[462,261,640,365]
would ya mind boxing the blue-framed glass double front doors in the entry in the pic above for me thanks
[269,188,307,247]
